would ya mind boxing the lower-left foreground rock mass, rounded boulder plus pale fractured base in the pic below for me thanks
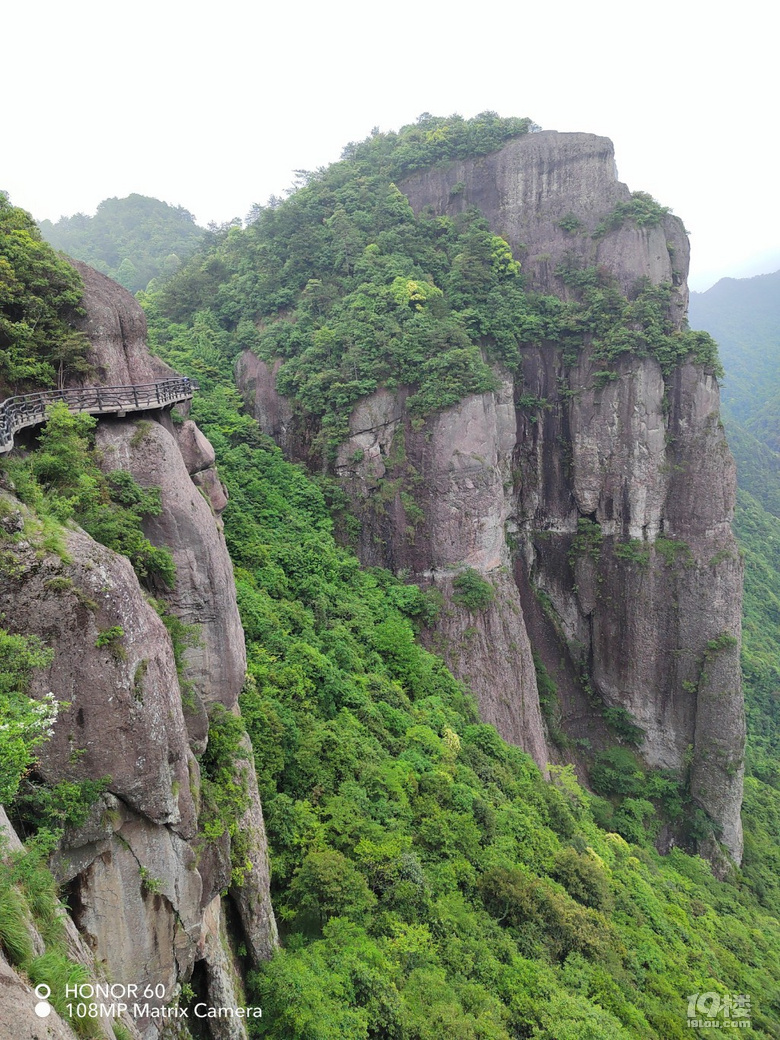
[0,505,204,1036]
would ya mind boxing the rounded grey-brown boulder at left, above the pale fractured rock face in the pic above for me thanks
[0,520,198,838]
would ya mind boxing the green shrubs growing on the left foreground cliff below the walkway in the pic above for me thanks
[0,404,170,835]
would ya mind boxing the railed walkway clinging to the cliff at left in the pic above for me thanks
[0,376,200,453]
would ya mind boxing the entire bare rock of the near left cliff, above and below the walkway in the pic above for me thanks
[0,264,276,1040]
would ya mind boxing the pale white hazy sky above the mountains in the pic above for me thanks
[0,0,780,289]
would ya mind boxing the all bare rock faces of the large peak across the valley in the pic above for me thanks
[237,132,745,861]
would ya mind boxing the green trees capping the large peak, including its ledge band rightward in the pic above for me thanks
[155,112,717,449]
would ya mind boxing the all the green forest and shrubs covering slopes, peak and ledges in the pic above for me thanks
[0,113,780,1040]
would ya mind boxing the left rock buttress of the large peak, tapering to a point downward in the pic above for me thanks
[336,372,547,770]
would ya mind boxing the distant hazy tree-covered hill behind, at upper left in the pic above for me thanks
[41,194,204,292]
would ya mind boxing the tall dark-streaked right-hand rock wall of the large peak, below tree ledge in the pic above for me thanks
[515,348,745,859]
